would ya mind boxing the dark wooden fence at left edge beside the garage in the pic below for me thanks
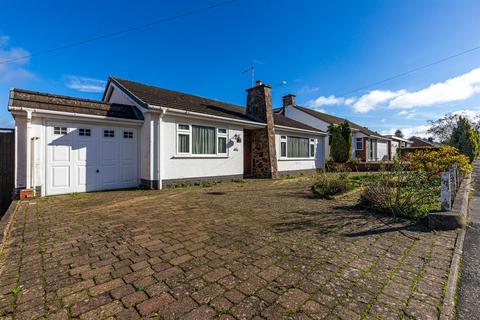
[0,128,15,217]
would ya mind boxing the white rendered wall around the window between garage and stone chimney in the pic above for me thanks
[160,115,244,180]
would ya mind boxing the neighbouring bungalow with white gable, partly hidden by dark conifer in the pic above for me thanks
[278,94,392,162]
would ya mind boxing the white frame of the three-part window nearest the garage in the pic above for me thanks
[175,122,229,158]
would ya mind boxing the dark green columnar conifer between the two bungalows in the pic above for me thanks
[328,121,352,163]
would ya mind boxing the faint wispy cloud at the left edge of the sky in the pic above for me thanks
[0,35,35,86]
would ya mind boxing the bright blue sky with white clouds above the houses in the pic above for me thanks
[0,0,480,138]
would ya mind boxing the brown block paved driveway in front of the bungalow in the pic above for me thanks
[0,178,456,320]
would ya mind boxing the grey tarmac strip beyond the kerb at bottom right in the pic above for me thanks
[457,160,480,320]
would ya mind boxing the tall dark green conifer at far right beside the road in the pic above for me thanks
[450,116,480,162]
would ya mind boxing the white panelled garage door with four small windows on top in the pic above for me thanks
[46,123,138,195]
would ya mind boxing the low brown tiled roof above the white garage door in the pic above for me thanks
[9,89,143,120]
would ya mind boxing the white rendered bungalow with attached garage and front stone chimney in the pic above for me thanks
[8,77,326,196]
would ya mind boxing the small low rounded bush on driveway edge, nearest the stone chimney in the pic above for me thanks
[312,172,354,199]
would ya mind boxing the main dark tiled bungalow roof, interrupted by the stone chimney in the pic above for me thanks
[104,77,322,132]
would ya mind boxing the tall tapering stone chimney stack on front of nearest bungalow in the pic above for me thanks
[246,81,278,179]
